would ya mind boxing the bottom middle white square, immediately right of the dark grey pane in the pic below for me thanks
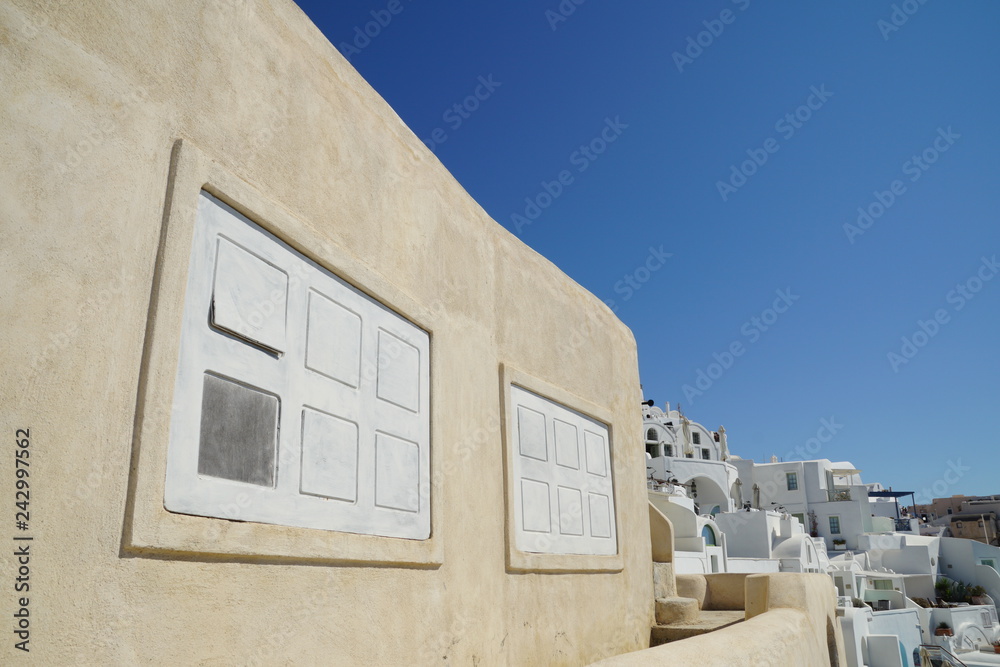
[302,408,358,502]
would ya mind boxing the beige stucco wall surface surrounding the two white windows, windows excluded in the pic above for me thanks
[0,0,652,665]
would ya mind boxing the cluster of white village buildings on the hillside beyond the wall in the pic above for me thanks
[642,402,1000,667]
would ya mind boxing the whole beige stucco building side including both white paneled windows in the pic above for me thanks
[0,0,652,665]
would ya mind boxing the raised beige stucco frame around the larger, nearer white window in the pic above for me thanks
[122,140,447,569]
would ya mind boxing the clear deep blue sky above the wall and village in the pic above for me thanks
[299,0,1000,495]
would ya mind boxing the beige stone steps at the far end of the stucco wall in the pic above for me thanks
[649,563,746,646]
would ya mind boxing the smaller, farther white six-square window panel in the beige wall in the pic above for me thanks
[510,386,618,555]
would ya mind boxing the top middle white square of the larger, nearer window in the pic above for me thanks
[306,292,361,388]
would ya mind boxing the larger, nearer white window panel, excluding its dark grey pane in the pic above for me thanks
[164,193,430,539]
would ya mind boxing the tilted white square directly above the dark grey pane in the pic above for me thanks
[212,238,288,352]
